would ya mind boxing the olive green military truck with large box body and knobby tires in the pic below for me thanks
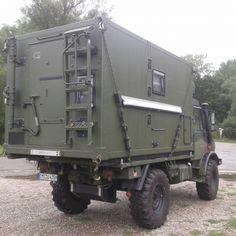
[4,18,221,229]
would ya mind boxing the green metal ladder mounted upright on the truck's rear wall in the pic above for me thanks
[63,32,94,145]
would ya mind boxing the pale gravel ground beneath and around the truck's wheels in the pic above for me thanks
[0,175,236,236]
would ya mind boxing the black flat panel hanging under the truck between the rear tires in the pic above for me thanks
[71,184,116,203]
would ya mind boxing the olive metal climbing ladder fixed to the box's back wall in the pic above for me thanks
[63,27,96,146]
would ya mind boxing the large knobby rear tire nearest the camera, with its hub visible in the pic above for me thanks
[130,169,170,229]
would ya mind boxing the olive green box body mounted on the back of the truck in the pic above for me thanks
[5,19,195,164]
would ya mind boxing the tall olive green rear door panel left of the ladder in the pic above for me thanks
[27,39,65,146]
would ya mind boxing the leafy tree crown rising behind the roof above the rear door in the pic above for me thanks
[18,0,110,33]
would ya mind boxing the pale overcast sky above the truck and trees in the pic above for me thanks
[0,0,236,68]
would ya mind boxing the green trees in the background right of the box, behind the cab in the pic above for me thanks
[183,54,236,139]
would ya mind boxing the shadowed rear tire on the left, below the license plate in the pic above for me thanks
[52,181,90,214]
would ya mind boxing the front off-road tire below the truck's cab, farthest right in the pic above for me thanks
[196,159,219,200]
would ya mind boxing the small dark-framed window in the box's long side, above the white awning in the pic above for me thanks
[152,70,165,96]
